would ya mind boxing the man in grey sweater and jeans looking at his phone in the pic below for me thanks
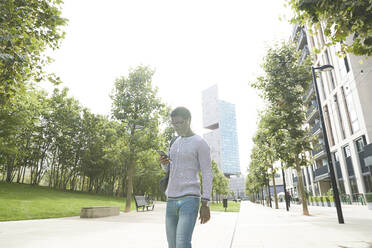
[160,107,213,248]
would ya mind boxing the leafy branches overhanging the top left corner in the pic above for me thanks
[0,0,67,104]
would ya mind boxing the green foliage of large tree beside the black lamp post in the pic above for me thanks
[247,43,312,203]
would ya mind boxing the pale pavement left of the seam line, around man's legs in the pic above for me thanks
[0,203,238,248]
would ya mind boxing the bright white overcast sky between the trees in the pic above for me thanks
[43,0,292,174]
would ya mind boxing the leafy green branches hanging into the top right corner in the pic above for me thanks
[287,0,372,56]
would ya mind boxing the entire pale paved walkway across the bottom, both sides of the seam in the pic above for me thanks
[0,202,372,248]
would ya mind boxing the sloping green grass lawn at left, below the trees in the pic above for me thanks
[0,182,136,221]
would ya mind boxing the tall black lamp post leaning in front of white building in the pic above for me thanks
[311,65,344,224]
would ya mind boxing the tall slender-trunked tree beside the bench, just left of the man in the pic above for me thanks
[111,66,164,212]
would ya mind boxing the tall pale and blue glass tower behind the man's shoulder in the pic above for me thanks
[202,85,241,177]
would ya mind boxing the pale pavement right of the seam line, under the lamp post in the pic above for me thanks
[232,201,372,248]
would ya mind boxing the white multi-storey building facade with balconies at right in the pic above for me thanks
[286,22,372,201]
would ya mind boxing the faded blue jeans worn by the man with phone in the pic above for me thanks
[165,196,200,248]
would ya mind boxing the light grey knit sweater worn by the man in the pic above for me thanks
[162,134,213,200]
